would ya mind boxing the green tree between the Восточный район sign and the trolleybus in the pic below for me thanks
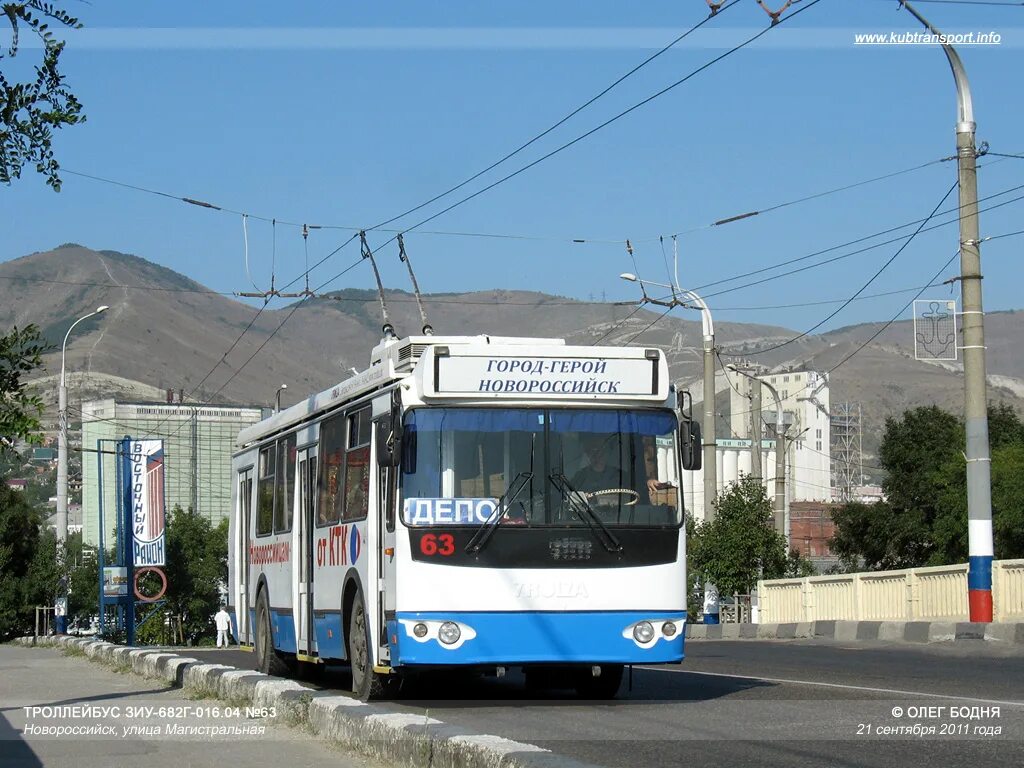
[164,507,227,644]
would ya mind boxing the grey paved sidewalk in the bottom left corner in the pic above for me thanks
[0,645,380,768]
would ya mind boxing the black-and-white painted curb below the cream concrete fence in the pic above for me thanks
[686,621,1024,646]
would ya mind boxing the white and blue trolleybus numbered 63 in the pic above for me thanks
[228,336,700,699]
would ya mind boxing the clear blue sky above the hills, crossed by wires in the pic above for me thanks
[0,0,1024,330]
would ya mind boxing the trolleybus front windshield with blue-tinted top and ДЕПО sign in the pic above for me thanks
[401,408,681,527]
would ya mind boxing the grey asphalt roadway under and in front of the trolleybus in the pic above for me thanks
[189,641,1024,768]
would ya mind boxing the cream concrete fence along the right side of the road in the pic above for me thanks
[758,560,1024,624]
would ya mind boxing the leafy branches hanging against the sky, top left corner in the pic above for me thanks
[0,0,85,191]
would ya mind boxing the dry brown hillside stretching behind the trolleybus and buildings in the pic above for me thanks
[0,245,1024,466]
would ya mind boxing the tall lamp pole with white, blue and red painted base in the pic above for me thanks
[901,0,993,622]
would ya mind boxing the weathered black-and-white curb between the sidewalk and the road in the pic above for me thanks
[13,635,598,768]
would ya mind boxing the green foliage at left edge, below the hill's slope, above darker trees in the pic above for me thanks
[0,326,50,451]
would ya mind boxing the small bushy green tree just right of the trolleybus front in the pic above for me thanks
[689,477,790,594]
